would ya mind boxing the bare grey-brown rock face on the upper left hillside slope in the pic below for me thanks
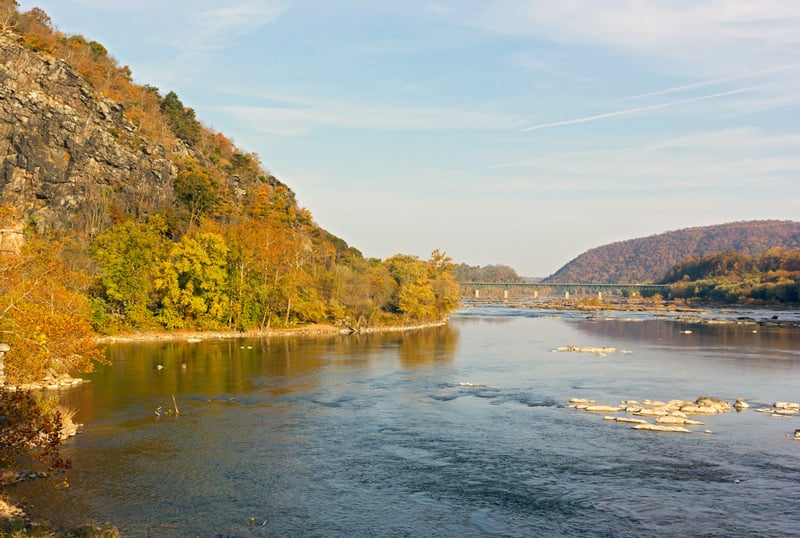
[0,37,176,232]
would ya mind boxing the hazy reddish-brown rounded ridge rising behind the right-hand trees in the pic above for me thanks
[544,220,800,284]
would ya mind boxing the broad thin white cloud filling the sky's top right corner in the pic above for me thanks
[460,0,800,76]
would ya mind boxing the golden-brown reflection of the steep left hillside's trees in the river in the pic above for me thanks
[65,325,459,422]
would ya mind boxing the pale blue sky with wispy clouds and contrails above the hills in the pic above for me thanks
[19,0,800,277]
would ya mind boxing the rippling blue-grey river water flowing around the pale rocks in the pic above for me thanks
[12,307,800,537]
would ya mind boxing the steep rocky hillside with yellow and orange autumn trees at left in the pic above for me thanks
[0,0,459,381]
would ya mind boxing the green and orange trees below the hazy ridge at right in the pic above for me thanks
[661,247,800,304]
